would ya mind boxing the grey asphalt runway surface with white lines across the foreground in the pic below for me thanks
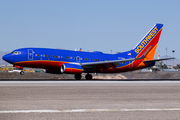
[0,80,180,120]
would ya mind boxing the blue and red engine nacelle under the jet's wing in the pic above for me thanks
[60,63,83,74]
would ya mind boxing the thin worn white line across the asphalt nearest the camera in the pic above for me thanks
[0,108,180,113]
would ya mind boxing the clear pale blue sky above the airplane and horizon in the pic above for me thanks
[0,0,180,58]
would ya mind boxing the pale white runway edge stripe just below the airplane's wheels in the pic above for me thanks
[0,80,180,87]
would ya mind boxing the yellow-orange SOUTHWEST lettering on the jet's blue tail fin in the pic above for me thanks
[134,27,158,54]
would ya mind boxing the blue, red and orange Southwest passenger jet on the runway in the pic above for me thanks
[3,24,173,80]
